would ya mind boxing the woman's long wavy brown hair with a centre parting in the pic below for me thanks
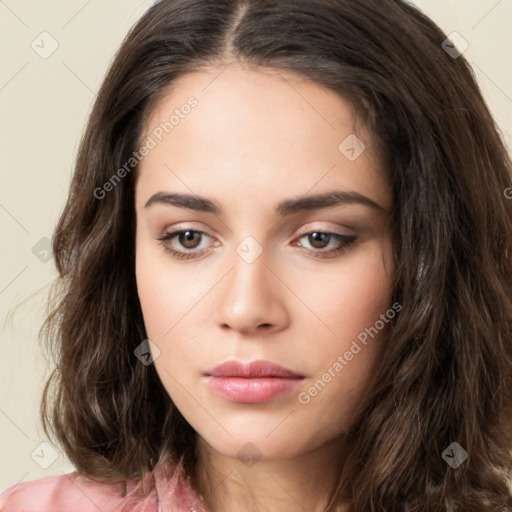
[40,0,512,512]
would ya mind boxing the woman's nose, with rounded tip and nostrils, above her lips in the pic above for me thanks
[216,244,289,336]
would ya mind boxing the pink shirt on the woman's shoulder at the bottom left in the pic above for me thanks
[0,458,208,512]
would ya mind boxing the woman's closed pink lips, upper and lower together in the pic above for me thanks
[203,360,305,404]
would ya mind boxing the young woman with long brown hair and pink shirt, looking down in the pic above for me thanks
[0,0,512,512]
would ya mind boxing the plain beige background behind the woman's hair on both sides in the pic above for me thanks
[0,0,512,493]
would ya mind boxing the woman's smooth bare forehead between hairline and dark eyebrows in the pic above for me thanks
[135,64,390,214]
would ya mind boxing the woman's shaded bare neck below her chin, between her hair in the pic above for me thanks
[196,436,346,512]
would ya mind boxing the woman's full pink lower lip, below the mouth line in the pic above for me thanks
[207,376,303,404]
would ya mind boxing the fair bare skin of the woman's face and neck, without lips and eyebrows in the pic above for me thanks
[135,63,394,512]
